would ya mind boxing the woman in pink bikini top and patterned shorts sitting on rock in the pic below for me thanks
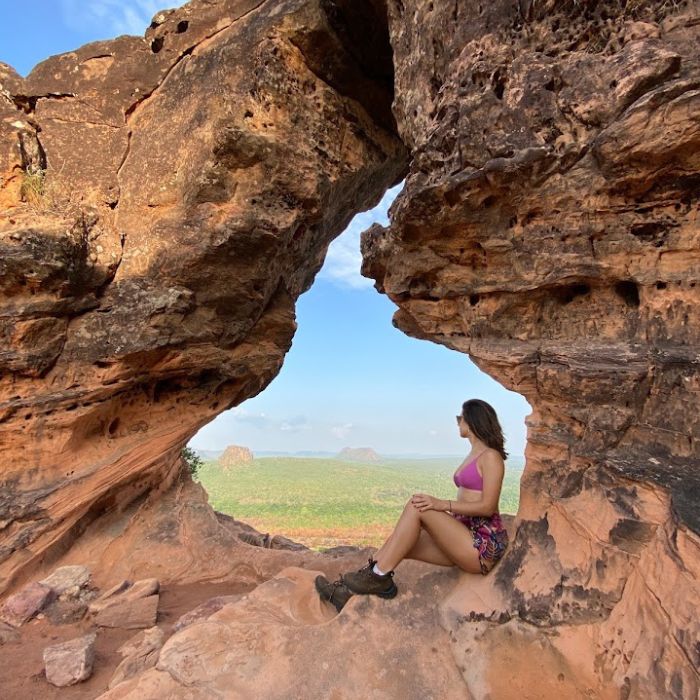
[316,399,508,610]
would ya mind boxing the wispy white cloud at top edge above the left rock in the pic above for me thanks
[61,0,185,38]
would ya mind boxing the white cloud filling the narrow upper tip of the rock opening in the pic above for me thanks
[318,182,403,289]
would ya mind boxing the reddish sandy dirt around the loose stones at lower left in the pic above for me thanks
[0,583,254,700]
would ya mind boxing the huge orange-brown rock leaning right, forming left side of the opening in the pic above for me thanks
[0,0,406,591]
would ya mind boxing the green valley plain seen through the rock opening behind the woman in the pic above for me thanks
[198,457,522,549]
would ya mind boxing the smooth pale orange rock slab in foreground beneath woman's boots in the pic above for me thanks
[95,562,465,700]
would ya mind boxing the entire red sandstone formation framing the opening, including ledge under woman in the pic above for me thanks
[0,0,700,700]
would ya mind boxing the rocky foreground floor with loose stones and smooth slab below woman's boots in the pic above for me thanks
[0,524,476,700]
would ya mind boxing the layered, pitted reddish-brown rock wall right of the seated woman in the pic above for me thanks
[362,0,700,698]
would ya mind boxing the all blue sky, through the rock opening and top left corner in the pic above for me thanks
[0,0,530,456]
